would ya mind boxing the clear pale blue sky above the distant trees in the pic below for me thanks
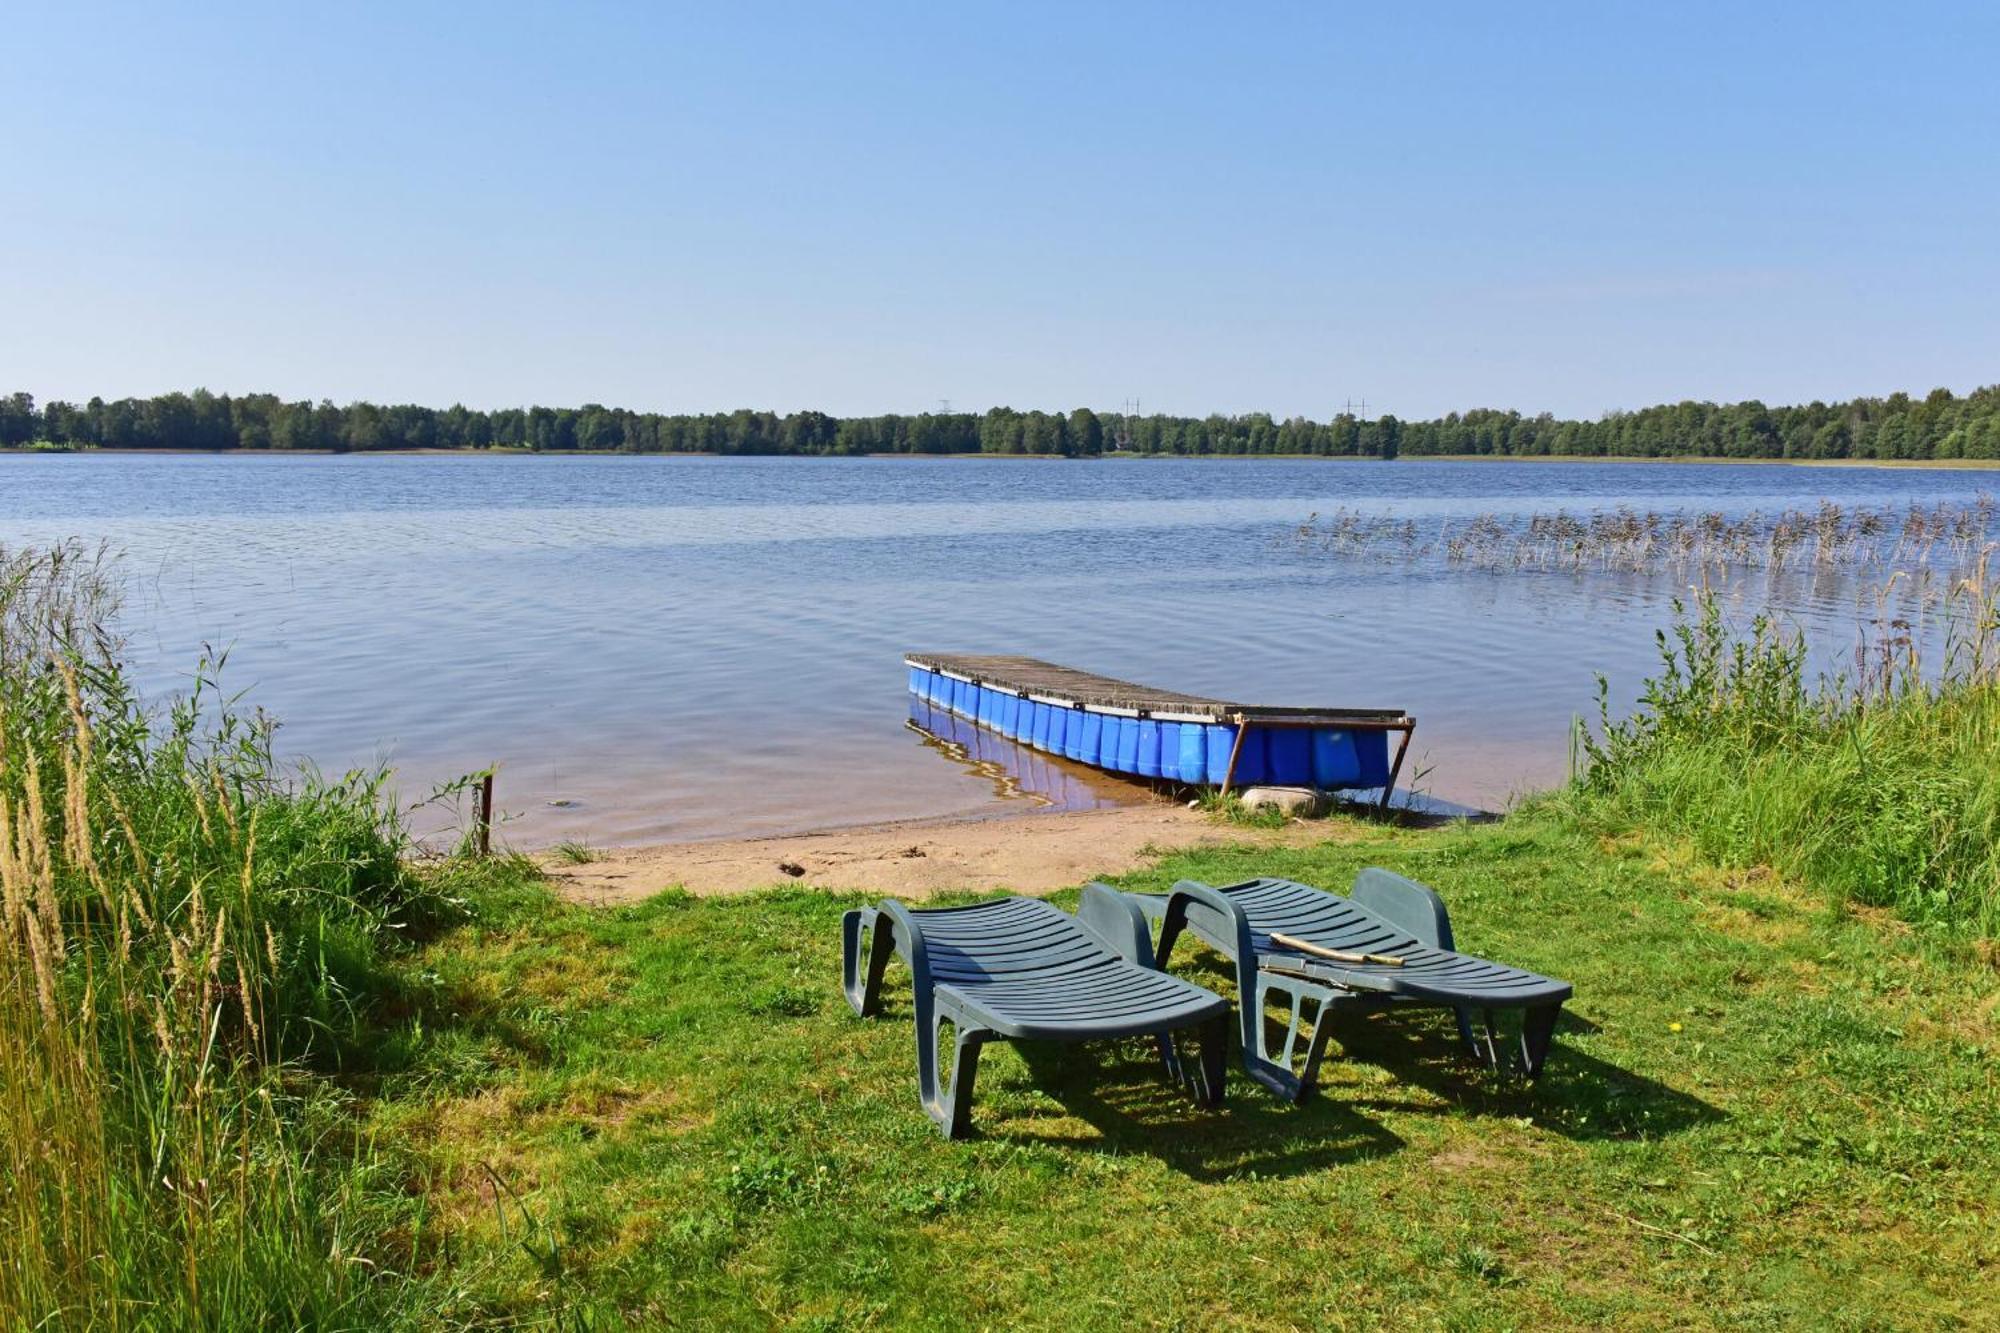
[0,2,2000,416]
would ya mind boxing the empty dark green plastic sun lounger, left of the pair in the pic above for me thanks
[840,885,1230,1139]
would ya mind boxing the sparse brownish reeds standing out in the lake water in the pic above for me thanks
[1290,494,1996,574]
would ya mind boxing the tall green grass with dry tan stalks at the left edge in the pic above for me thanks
[0,546,464,1329]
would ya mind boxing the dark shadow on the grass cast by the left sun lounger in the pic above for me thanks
[996,1041,1404,1181]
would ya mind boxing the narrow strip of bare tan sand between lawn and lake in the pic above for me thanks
[536,803,1366,905]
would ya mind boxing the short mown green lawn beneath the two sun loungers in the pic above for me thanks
[362,815,2000,1329]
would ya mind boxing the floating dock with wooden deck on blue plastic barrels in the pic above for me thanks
[904,652,1416,805]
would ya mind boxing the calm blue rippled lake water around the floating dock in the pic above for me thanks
[0,454,2000,845]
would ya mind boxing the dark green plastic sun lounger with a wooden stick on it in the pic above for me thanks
[1126,869,1570,1101]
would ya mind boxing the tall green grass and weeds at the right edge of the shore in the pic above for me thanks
[1558,558,2000,941]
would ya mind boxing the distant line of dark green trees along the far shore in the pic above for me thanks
[0,384,2000,458]
